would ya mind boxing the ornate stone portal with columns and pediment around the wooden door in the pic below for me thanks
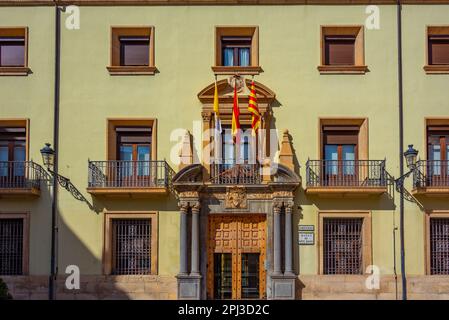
[173,80,301,299]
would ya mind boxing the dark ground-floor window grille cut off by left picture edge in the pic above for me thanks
[0,219,23,275]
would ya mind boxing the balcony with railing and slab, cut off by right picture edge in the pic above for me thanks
[412,160,449,196]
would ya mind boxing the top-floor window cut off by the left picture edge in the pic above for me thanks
[0,27,29,75]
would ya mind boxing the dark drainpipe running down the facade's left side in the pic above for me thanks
[48,0,61,300]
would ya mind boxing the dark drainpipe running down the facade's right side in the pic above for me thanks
[397,0,407,300]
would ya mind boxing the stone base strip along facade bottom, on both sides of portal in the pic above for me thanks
[1,275,449,300]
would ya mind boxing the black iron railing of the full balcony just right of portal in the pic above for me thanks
[306,160,388,188]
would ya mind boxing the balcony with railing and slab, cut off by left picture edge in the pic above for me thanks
[0,161,43,197]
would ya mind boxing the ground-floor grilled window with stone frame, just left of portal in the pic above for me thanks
[104,212,157,275]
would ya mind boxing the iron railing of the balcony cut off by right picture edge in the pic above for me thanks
[413,160,449,189]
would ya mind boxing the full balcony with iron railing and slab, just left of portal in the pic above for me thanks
[87,160,173,198]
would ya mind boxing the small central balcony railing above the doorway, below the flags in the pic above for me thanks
[211,163,262,184]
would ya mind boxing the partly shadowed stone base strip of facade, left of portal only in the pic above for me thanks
[1,276,177,300]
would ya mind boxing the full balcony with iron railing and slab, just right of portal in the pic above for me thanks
[306,160,388,197]
